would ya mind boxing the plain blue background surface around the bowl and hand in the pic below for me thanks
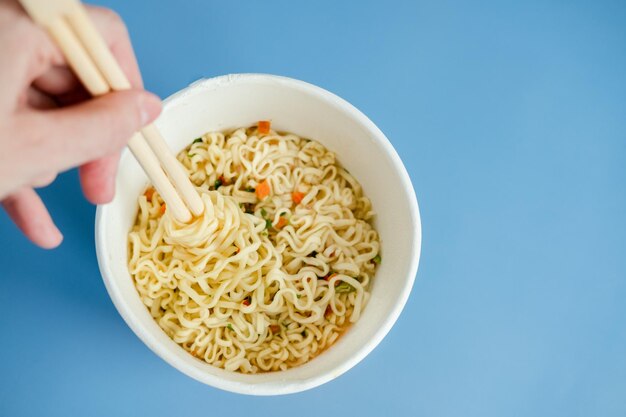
[0,0,626,417]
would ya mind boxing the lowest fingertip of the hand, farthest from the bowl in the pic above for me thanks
[2,188,63,249]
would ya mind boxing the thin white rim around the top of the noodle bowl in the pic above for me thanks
[95,73,422,395]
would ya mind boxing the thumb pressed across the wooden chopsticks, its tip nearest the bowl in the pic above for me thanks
[23,90,161,171]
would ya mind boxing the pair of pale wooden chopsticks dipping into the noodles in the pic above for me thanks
[19,0,204,223]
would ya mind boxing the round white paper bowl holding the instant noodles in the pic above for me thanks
[96,74,421,395]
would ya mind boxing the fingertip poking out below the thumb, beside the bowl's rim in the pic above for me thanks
[79,153,120,204]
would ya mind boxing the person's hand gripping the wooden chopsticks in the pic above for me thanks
[0,0,161,248]
